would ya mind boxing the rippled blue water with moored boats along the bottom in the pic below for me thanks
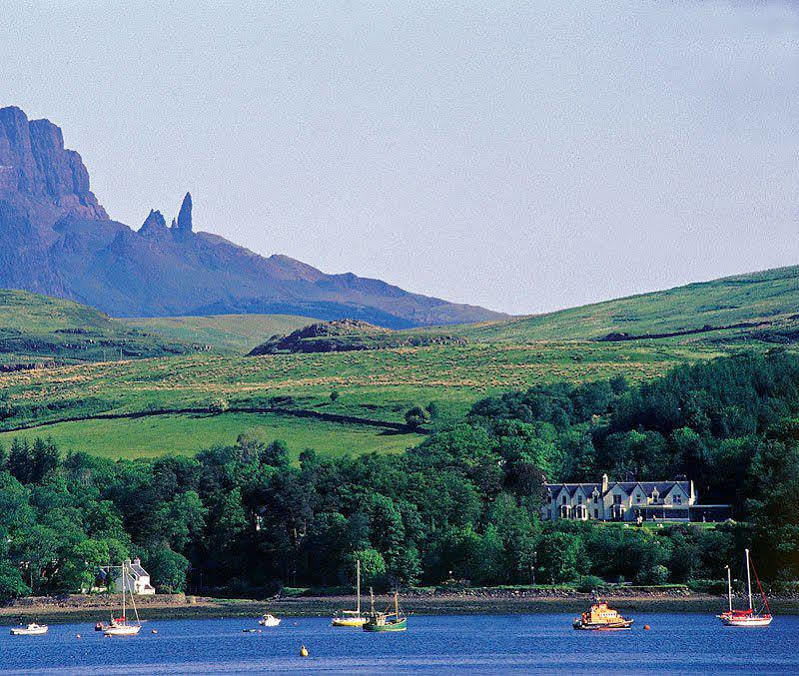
[0,613,799,674]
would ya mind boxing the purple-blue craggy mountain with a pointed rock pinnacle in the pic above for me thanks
[0,108,504,328]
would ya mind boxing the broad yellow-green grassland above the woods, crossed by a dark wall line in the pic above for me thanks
[0,342,723,457]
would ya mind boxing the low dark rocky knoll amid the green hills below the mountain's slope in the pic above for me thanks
[249,319,466,356]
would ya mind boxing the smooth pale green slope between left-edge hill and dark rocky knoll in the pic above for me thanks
[114,315,316,354]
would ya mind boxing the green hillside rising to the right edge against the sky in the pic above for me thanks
[450,266,799,343]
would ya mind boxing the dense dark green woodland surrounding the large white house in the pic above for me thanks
[0,352,799,598]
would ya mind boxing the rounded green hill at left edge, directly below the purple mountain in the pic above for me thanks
[0,289,195,370]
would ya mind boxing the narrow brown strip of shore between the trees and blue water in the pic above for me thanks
[0,592,799,625]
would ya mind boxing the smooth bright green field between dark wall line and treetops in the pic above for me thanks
[0,413,423,459]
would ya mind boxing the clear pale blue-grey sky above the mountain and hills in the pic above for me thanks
[0,0,799,314]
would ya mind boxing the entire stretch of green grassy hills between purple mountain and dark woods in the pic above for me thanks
[0,268,799,457]
